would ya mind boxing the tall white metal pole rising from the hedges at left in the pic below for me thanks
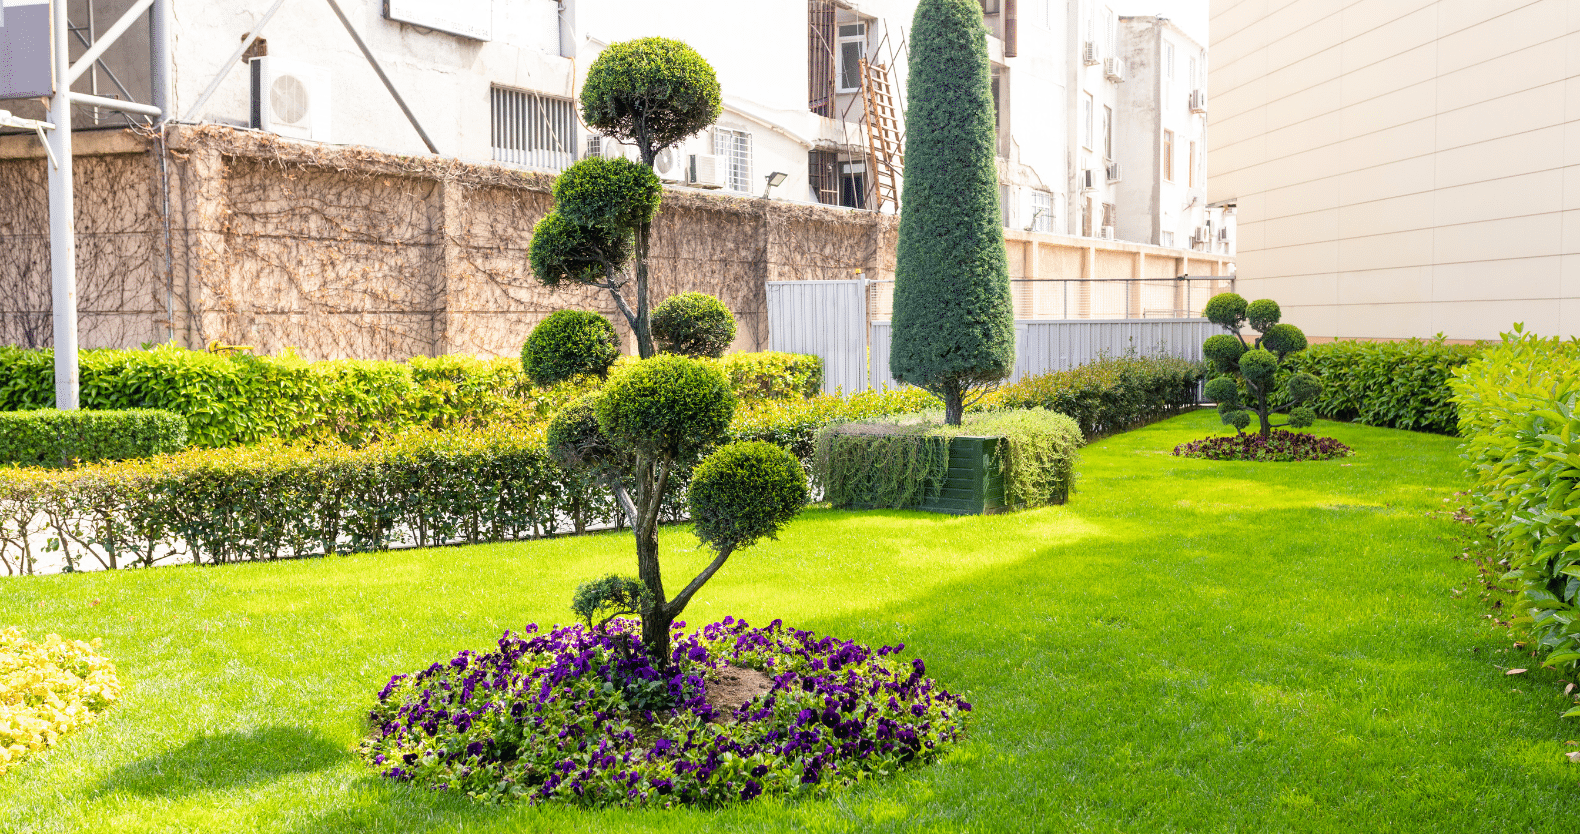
[49,0,77,409]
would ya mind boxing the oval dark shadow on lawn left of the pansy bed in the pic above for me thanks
[98,727,351,796]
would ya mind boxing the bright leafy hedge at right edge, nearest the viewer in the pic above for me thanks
[1450,327,1580,688]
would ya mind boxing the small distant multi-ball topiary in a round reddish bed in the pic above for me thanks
[1201,292,1322,438]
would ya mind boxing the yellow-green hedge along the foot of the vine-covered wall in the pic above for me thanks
[0,344,568,449]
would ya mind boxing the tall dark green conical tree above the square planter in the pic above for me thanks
[890,0,1014,425]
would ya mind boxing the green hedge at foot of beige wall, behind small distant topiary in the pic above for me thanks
[1280,336,1484,434]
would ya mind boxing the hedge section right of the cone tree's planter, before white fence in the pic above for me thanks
[981,355,1204,441]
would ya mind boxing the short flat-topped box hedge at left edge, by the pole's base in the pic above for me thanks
[0,409,186,466]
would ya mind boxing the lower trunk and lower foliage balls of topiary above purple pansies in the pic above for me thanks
[548,355,806,665]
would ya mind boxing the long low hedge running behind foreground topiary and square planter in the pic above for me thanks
[0,352,1198,573]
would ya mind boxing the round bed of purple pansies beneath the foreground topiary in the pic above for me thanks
[362,618,972,806]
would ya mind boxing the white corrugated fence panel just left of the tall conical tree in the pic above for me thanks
[768,280,865,393]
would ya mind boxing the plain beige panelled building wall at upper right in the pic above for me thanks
[1207,0,1580,340]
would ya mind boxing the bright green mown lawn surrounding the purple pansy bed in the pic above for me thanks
[0,412,1580,834]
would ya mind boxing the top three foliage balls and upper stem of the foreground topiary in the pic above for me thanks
[529,38,722,359]
